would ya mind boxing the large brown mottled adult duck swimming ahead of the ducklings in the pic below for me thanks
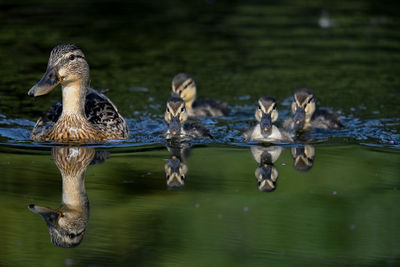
[28,44,129,143]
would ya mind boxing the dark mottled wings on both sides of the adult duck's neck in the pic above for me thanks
[31,89,129,140]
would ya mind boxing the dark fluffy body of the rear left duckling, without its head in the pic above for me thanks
[192,99,229,117]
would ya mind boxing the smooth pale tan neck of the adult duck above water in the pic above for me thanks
[62,81,88,117]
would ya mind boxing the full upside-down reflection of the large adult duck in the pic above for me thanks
[29,147,95,248]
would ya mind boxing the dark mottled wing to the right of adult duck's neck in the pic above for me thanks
[85,89,129,138]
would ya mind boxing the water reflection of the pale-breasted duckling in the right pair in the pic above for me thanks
[250,146,283,192]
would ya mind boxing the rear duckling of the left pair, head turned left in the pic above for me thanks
[172,73,229,117]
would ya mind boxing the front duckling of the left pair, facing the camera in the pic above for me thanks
[164,94,212,140]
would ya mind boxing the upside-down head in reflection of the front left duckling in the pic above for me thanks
[164,156,188,189]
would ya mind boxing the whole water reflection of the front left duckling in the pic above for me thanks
[164,143,191,189]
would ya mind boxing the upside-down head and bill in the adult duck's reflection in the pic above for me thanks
[28,204,87,248]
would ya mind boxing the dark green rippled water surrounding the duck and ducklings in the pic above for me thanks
[0,0,400,266]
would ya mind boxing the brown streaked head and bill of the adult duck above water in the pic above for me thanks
[28,44,89,96]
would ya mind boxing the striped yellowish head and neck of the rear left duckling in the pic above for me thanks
[172,73,196,109]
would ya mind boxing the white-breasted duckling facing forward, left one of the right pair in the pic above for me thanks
[243,96,293,143]
